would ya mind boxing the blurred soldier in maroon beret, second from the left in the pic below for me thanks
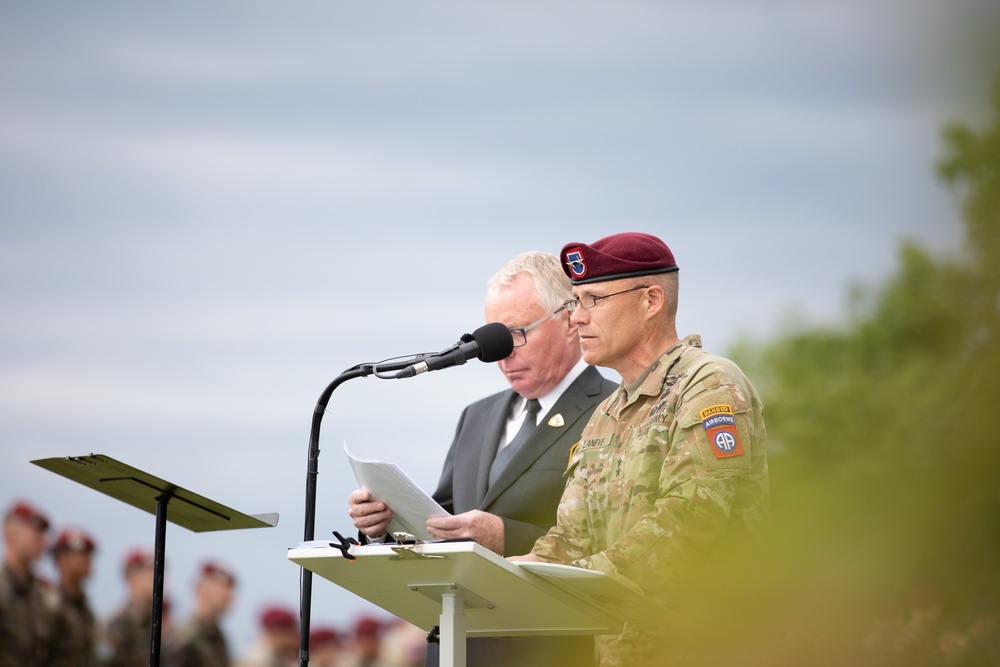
[45,529,97,667]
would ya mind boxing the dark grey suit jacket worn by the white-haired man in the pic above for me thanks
[425,366,618,667]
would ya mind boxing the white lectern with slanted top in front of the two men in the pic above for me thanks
[288,541,643,667]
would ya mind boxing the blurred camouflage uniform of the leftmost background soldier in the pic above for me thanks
[0,565,51,667]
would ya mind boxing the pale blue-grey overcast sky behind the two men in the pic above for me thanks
[0,0,996,653]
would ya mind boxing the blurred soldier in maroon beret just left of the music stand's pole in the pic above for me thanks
[102,550,154,667]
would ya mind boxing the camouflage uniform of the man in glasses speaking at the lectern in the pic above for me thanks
[533,336,769,667]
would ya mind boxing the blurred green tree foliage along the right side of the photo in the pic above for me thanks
[734,80,1000,665]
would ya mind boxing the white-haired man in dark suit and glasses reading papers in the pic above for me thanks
[349,252,617,667]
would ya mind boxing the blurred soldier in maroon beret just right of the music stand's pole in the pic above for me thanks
[163,563,236,667]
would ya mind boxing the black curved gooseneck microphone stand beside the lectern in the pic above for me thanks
[299,355,426,667]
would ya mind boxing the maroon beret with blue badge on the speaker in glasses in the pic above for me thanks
[560,232,677,285]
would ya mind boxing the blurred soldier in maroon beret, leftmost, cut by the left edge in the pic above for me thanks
[0,503,51,667]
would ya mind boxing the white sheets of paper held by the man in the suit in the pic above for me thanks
[344,442,448,540]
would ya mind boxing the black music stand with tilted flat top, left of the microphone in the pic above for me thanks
[32,454,278,667]
